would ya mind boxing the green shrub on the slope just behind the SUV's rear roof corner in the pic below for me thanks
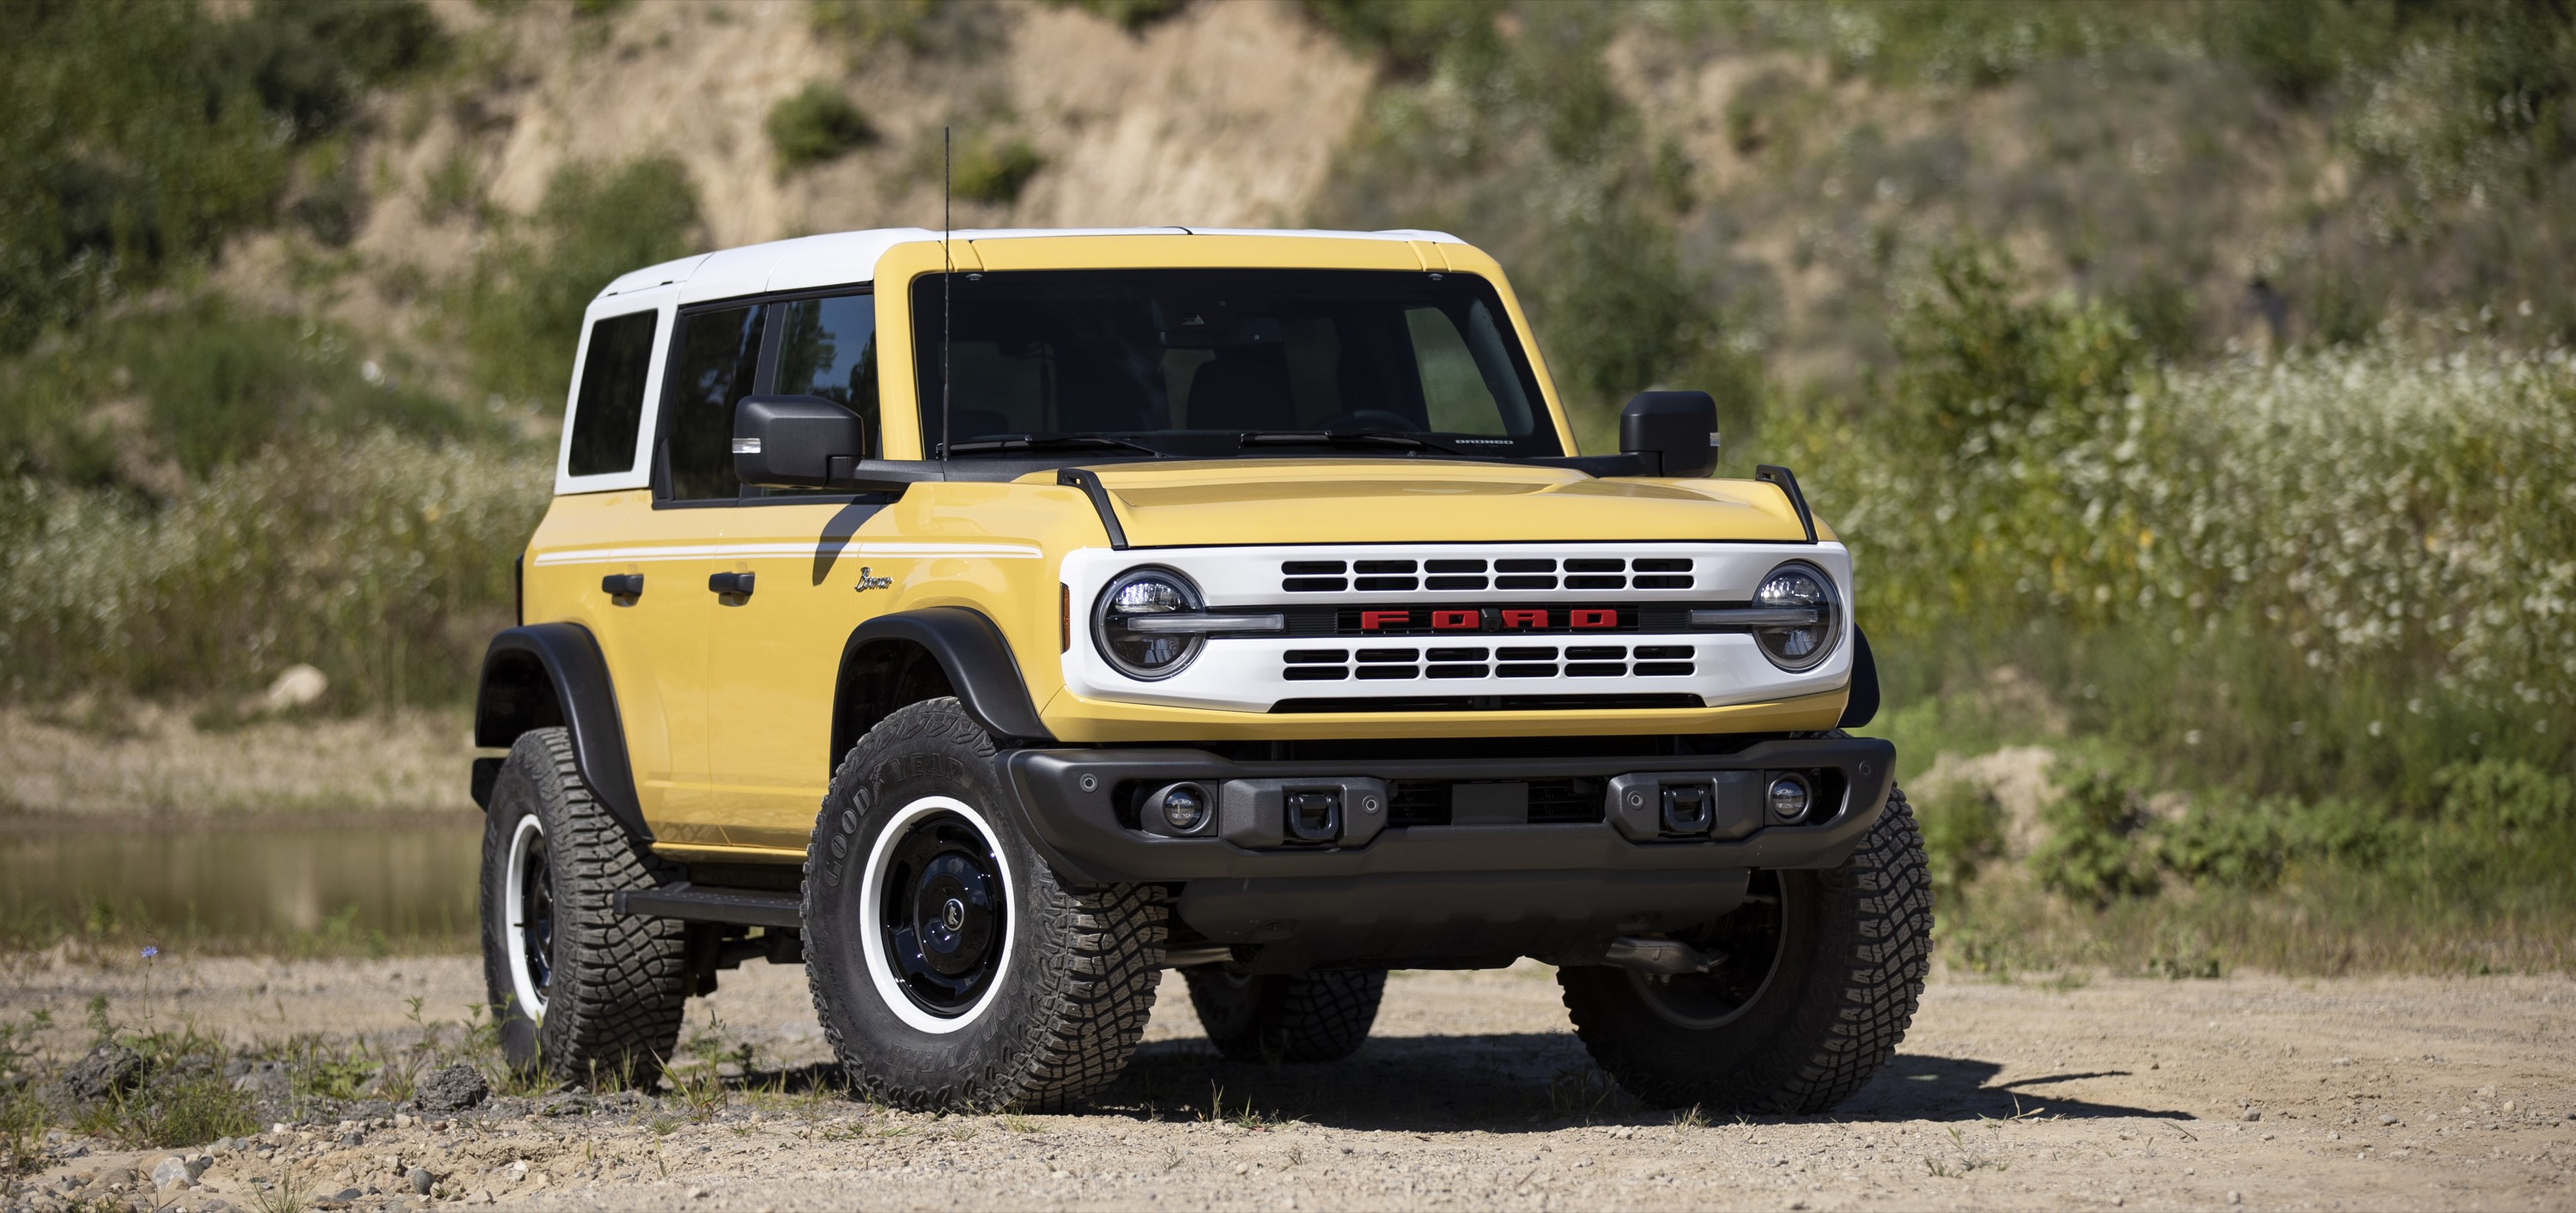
[459,157,706,407]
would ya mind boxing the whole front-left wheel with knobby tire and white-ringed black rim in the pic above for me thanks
[804,698,1164,1110]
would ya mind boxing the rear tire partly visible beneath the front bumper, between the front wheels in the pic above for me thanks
[1180,966,1386,1064]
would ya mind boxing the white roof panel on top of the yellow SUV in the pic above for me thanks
[600,227,1463,304]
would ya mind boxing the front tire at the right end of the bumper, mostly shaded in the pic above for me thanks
[1556,788,1932,1115]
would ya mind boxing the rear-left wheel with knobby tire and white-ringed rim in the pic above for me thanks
[482,729,688,1087]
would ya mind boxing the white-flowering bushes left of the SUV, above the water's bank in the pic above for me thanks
[0,435,551,706]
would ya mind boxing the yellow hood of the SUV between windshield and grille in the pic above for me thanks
[1046,458,1826,549]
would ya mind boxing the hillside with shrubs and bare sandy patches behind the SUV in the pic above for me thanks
[0,0,2576,968]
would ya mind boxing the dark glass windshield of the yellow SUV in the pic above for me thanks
[912,270,1564,458]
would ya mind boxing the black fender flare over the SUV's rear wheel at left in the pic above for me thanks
[474,623,652,840]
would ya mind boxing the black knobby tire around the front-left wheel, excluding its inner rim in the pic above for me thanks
[804,698,1167,1113]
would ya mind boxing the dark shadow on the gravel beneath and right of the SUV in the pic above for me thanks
[1095,1033,2192,1133]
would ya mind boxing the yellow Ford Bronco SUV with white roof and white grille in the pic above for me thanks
[474,229,1932,1113]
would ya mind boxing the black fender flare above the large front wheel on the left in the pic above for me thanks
[827,608,1054,765]
